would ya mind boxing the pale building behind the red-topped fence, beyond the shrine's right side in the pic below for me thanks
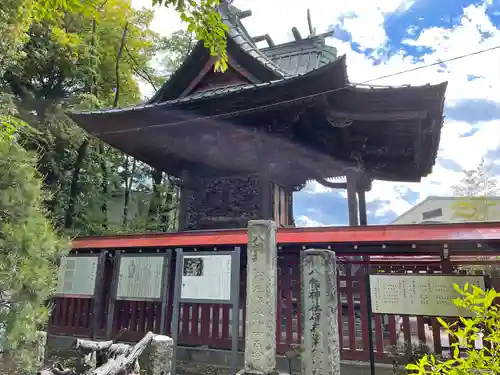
[392,196,500,224]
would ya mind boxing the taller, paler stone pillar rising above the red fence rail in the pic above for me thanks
[244,220,277,375]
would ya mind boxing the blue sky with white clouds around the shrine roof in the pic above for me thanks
[133,0,500,226]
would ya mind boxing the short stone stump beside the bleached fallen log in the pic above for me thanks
[141,335,174,375]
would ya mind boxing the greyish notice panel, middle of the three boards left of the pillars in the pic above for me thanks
[116,254,166,300]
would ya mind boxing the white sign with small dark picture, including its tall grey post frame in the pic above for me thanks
[170,247,240,375]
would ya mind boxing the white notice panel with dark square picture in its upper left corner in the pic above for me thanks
[181,254,231,301]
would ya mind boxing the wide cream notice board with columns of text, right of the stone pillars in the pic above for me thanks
[370,274,485,317]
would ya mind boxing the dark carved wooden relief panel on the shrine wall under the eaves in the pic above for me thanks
[186,175,262,230]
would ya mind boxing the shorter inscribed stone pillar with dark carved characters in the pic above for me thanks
[300,249,340,375]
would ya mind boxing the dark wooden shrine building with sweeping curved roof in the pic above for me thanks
[70,2,447,230]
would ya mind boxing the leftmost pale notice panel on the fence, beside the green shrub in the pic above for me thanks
[56,255,99,298]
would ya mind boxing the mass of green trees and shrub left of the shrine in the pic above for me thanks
[0,0,187,373]
